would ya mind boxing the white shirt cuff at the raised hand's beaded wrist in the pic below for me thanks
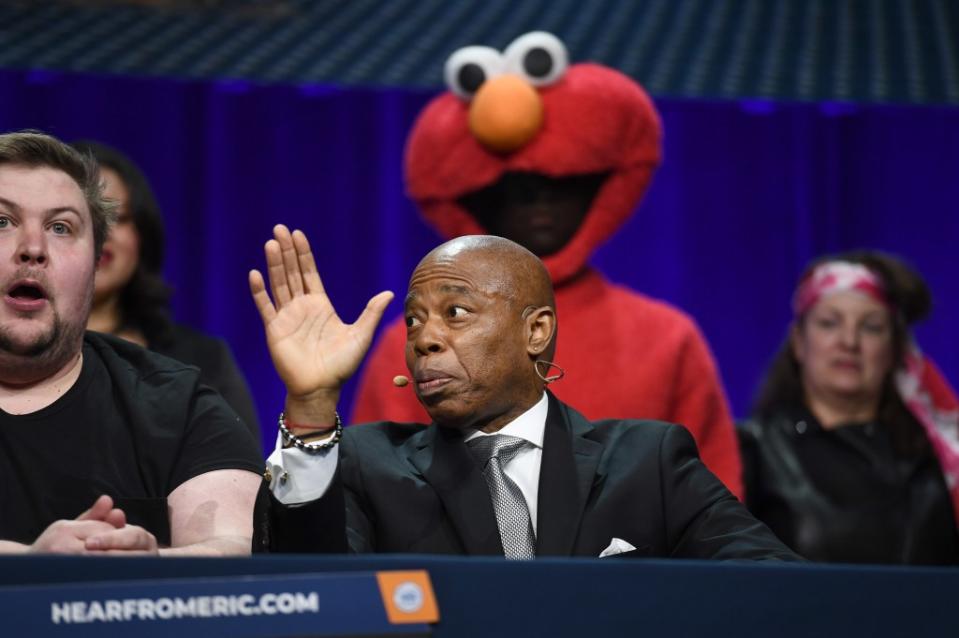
[266,434,339,505]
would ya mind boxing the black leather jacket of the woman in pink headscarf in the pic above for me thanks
[739,409,959,565]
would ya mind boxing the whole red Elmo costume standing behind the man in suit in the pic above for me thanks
[353,32,742,496]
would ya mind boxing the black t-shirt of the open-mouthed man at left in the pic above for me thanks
[0,333,262,545]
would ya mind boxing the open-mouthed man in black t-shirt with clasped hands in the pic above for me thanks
[0,131,259,555]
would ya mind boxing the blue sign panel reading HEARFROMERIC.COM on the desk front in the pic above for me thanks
[0,572,433,638]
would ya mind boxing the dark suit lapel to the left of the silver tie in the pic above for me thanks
[409,424,503,556]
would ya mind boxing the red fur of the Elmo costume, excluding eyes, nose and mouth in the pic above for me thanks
[352,55,742,496]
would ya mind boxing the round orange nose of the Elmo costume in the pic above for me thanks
[469,75,543,153]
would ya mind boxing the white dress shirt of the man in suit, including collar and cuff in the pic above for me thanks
[266,392,549,532]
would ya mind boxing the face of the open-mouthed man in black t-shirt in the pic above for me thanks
[0,164,94,364]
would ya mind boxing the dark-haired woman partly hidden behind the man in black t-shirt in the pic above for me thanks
[73,141,260,450]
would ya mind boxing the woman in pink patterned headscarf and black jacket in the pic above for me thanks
[740,251,959,564]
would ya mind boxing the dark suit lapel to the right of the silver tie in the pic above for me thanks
[536,392,603,556]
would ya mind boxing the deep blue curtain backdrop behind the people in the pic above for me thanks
[0,71,959,447]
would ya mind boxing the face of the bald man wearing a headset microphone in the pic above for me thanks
[405,251,539,427]
